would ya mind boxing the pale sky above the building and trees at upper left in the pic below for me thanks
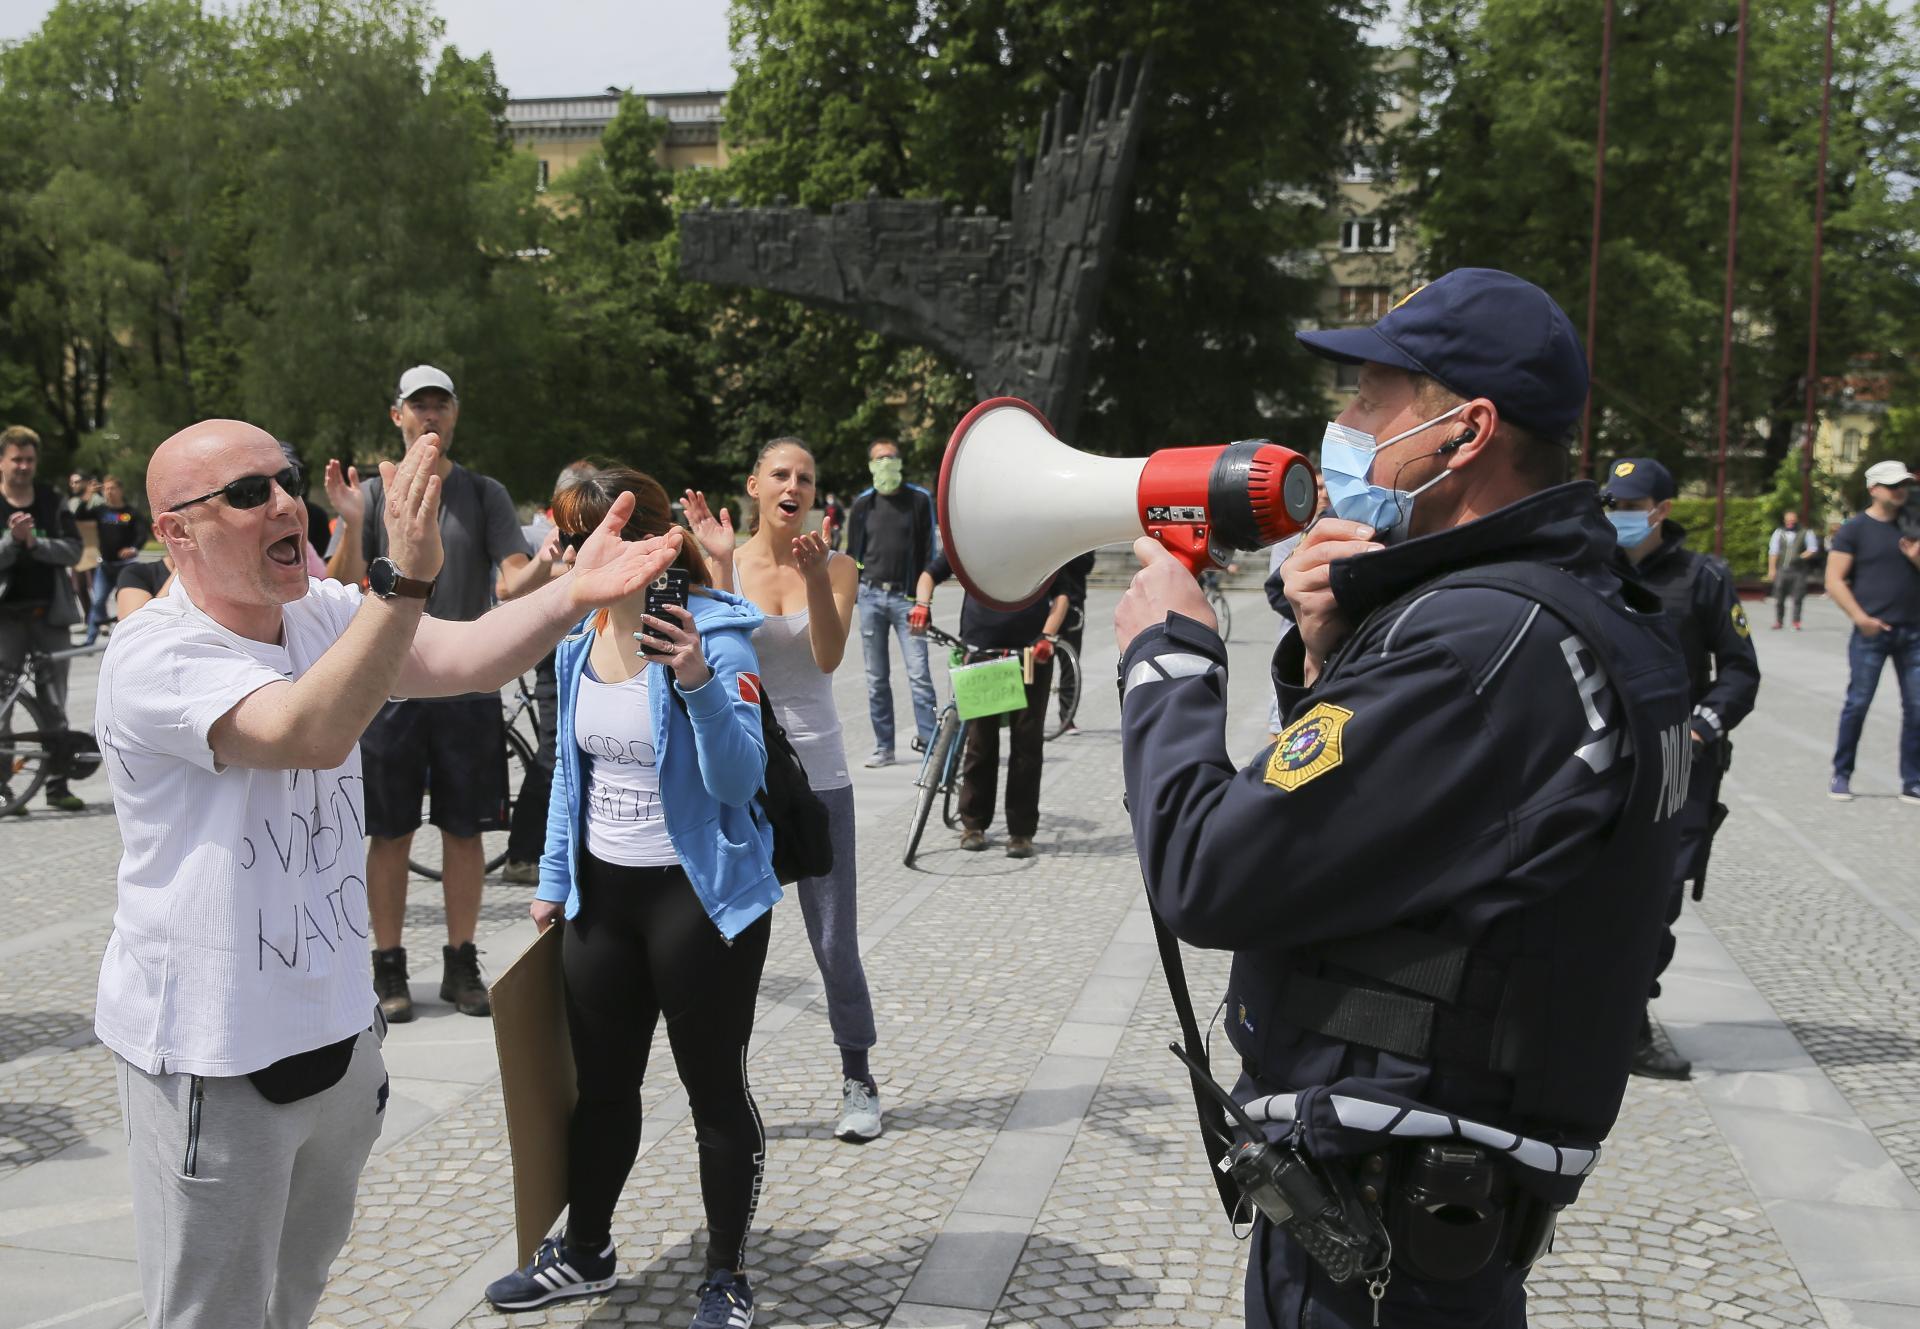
[0,0,733,96]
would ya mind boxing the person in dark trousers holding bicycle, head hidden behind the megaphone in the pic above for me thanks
[908,549,1068,858]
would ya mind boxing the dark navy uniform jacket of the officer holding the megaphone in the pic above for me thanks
[1121,482,1690,1202]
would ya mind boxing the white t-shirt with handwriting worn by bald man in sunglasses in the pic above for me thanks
[94,580,374,1075]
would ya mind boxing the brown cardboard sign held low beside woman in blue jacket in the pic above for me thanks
[488,924,580,1268]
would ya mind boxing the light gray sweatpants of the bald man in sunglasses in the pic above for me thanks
[115,1029,386,1329]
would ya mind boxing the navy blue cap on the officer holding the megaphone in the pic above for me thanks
[1296,267,1586,438]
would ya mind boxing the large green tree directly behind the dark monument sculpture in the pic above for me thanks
[714,0,1373,478]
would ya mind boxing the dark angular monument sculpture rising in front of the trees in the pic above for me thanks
[680,56,1148,440]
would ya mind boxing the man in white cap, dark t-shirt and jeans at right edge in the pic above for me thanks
[1826,461,1920,803]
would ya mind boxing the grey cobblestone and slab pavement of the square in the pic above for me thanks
[0,590,1920,1329]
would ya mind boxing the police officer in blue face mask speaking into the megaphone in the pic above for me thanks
[1116,269,1692,1327]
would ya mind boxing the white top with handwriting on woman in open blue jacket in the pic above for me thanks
[574,668,680,868]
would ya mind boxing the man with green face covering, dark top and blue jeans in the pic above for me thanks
[847,438,935,766]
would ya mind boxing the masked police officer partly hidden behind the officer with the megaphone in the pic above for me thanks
[1605,457,1761,1079]
